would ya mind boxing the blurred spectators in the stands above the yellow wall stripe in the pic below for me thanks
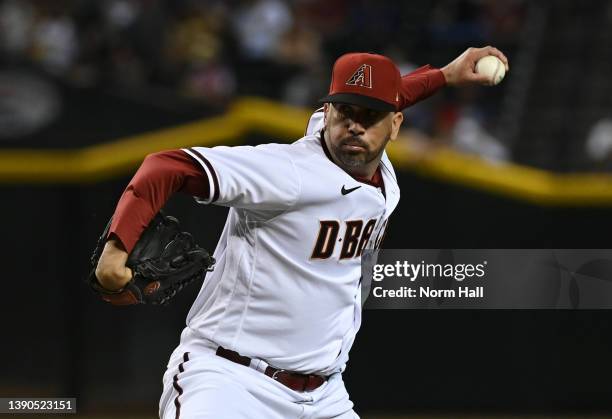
[0,0,525,159]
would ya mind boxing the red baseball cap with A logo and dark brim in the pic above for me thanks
[319,52,401,112]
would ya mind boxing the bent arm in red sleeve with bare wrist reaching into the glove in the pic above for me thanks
[96,150,209,290]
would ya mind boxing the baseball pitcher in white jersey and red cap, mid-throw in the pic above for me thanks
[96,47,508,419]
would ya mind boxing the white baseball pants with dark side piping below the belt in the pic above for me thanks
[159,350,359,419]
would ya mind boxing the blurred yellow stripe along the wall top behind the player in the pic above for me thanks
[0,98,612,206]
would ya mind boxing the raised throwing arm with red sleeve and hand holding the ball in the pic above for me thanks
[399,46,510,109]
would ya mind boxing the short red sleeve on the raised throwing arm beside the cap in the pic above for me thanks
[399,65,446,109]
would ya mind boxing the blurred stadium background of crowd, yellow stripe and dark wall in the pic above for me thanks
[0,0,612,419]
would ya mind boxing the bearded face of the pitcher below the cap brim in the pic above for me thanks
[325,103,403,177]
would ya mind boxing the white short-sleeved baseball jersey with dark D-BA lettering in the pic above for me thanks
[178,111,399,375]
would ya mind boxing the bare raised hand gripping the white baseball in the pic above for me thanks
[441,46,510,86]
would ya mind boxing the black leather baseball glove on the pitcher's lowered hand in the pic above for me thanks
[88,211,215,305]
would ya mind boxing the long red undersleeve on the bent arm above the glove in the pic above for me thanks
[109,150,210,253]
